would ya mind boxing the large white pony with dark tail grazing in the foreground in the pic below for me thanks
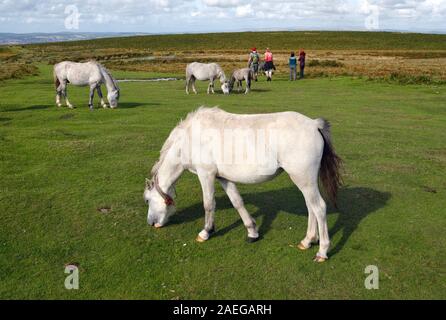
[144,108,341,262]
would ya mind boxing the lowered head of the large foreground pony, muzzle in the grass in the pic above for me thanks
[144,177,175,228]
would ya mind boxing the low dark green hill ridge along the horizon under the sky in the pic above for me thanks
[28,31,446,52]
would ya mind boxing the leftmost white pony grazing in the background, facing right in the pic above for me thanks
[53,61,119,109]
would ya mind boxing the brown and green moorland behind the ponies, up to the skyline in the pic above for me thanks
[0,31,446,84]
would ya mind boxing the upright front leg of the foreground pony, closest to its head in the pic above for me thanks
[196,172,215,242]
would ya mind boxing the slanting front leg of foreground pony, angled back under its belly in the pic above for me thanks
[218,179,259,242]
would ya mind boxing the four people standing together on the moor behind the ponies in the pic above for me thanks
[248,48,306,81]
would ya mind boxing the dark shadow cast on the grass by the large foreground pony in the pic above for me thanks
[170,187,391,255]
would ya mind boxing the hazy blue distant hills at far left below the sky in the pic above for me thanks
[0,32,150,45]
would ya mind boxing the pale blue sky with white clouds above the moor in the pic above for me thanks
[0,0,446,34]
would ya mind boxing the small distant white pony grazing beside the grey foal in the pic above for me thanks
[186,62,229,94]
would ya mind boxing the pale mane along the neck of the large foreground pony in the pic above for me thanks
[150,106,225,177]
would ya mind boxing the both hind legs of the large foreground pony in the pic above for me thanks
[291,176,330,262]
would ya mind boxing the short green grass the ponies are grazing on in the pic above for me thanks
[0,66,446,299]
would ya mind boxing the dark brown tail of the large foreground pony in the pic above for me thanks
[317,119,342,208]
